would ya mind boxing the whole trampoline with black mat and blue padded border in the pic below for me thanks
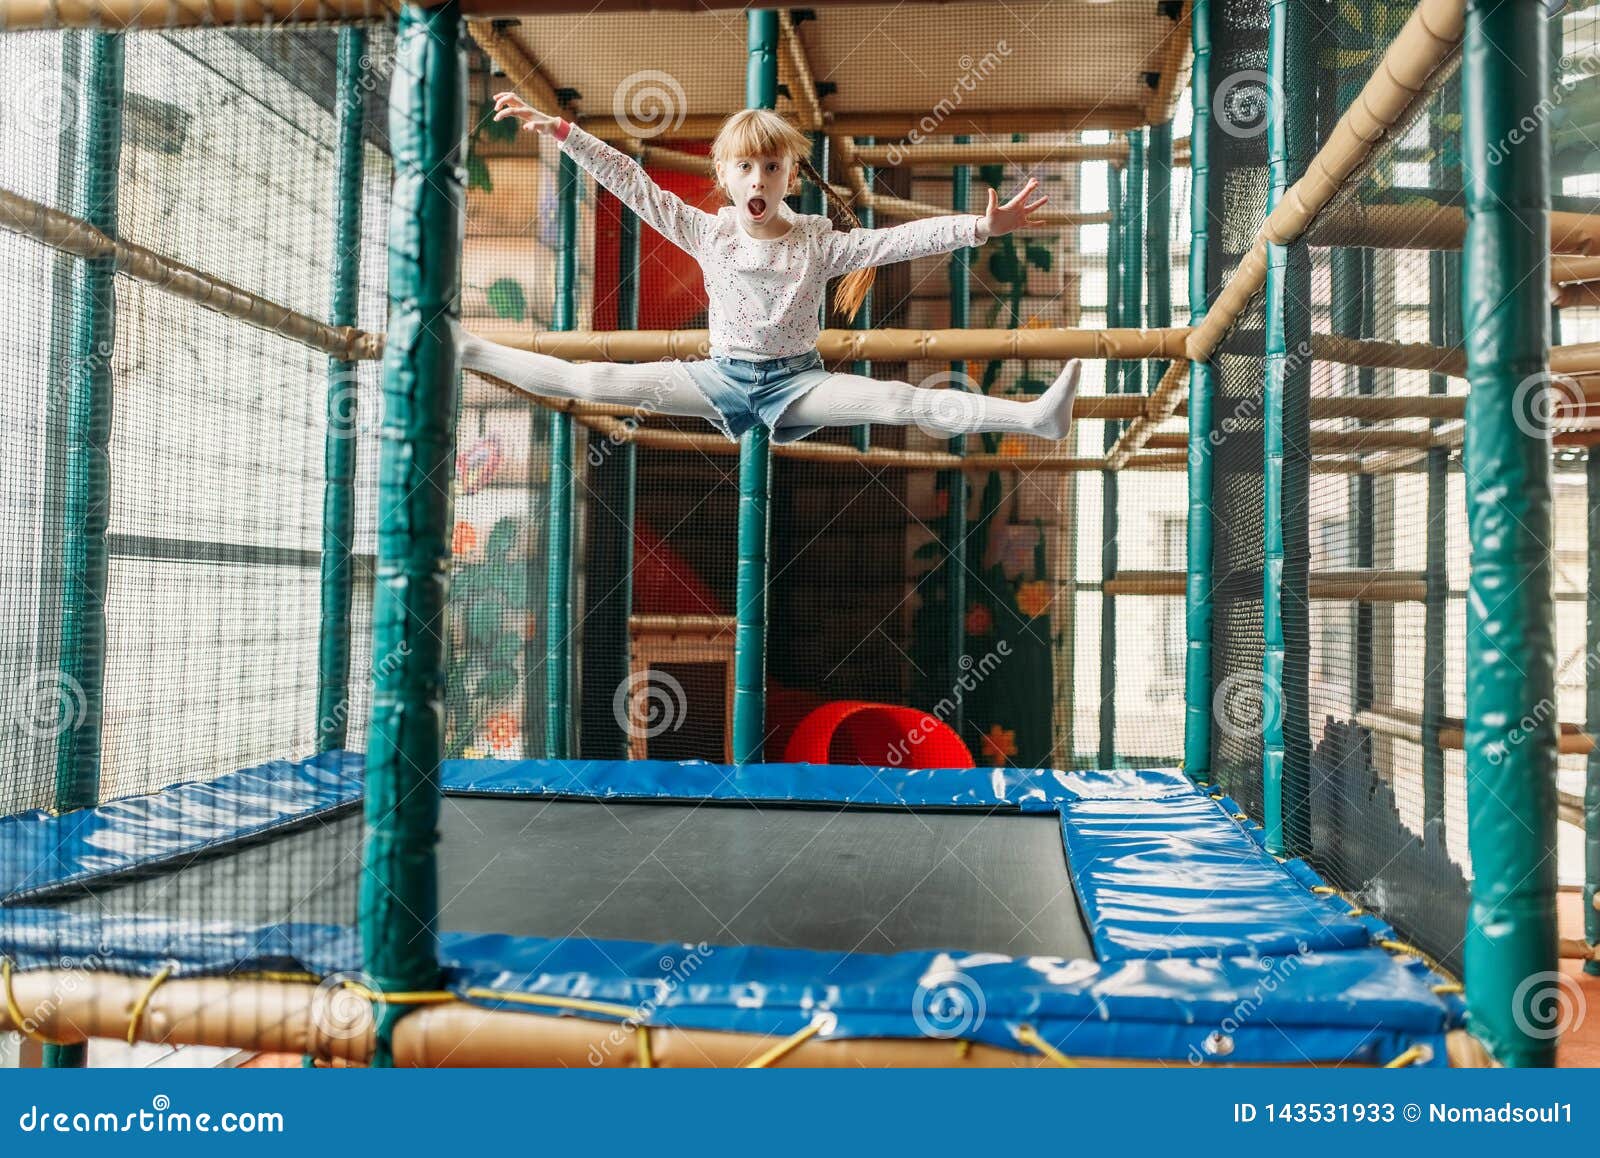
[0,752,1462,1065]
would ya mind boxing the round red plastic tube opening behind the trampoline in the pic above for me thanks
[784,699,973,768]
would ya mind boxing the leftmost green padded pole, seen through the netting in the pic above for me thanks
[43,32,123,1070]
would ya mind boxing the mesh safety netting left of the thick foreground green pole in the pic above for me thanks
[0,27,390,1042]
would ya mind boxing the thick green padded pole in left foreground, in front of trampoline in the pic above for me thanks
[360,0,467,1065]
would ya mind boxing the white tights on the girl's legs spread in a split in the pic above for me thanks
[461,333,1078,438]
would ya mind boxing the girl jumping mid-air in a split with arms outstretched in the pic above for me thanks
[461,93,1078,443]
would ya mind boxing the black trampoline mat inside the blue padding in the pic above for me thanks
[35,797,1093,958]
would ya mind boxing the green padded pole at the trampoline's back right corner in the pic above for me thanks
[1184,0,1216,784]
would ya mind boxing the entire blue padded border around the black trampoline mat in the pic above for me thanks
[0,753,1462,1064]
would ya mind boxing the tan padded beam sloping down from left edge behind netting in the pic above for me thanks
[0,189,382,361]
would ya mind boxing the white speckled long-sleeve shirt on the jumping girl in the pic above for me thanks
[557,123,986,360]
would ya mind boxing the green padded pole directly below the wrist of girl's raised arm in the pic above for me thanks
[544,152,578,760]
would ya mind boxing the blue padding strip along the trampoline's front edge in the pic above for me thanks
[0,910,1461,1064]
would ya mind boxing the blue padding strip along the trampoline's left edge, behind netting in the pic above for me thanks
[0,752,365,900]
